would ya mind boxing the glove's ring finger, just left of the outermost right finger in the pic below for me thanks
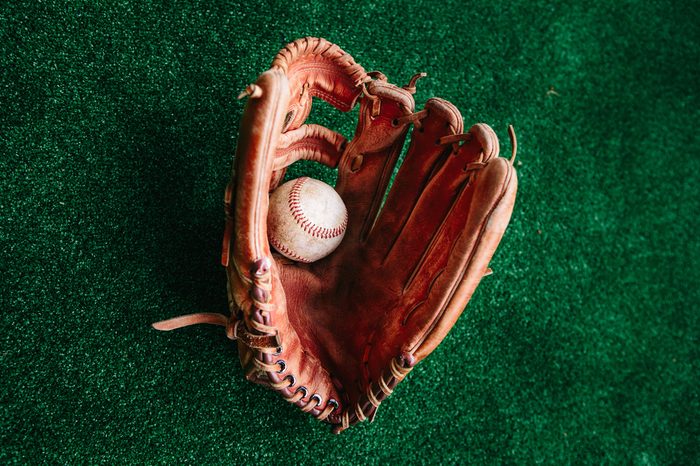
[384,125,495,289]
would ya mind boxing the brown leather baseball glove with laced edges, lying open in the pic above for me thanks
[154,38,517,432]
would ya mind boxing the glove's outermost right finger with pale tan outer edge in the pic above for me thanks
[369,158,517,371]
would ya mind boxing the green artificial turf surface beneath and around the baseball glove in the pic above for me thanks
[0,0,700,465]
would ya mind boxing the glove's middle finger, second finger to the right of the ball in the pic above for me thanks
[367,98,463,261]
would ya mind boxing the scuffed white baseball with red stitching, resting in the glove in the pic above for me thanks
[267,177,348,262]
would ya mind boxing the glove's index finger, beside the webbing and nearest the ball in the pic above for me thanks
[336,81,414,246]
